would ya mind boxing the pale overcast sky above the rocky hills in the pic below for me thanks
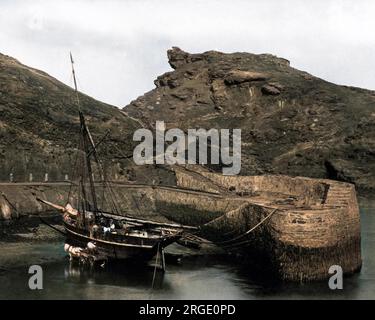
[0,0,375,107]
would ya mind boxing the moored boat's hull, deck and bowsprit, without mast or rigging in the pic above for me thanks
[38,199,196,268]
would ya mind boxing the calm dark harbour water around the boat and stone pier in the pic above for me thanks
[0,199,375,299]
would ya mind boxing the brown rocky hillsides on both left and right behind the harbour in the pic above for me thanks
[0,48,375,192]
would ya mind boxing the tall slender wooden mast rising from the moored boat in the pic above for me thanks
[70,52,98,214]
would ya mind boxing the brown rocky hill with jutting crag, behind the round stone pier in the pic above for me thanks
[123,48,375,192]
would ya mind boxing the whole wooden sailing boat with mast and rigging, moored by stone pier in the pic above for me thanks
[38,56,197,269]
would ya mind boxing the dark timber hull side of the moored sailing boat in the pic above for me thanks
[64,222,180,262]
